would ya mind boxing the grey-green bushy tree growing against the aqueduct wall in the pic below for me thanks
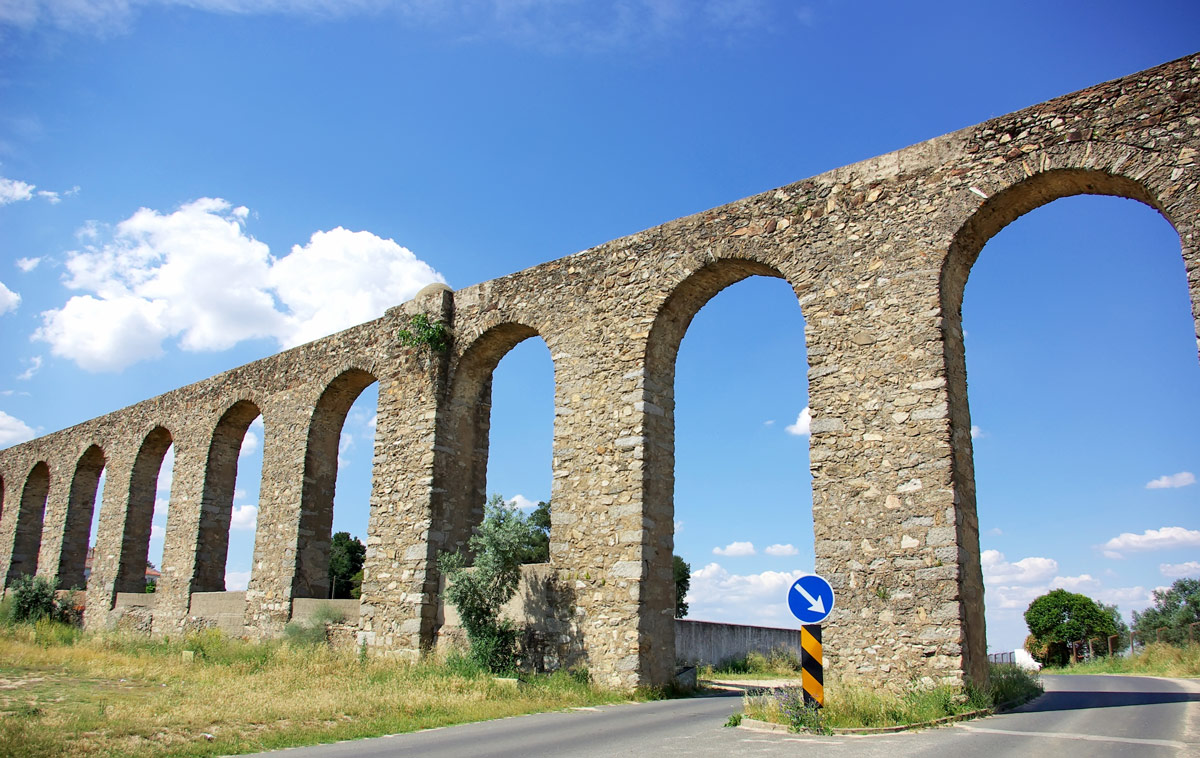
[438,495,529,672]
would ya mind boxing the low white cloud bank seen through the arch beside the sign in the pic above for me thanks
[686,564,804,627]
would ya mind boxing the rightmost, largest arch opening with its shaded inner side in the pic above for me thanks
[942,178,1200,679]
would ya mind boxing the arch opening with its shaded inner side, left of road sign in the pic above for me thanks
[641,260,814,644]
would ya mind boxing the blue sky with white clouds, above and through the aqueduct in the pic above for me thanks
[0,0,1200,650]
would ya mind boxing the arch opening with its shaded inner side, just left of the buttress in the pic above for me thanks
[293,368,377,598]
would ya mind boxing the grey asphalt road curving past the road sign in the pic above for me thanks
[236,676,1200,758]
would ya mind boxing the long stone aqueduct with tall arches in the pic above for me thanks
[0,55,1200,686]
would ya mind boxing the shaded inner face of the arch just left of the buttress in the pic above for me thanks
[292,368,377,597]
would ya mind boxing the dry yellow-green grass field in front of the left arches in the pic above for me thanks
[0,622,629,757]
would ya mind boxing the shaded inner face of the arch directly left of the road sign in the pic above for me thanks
[638,258,816,675]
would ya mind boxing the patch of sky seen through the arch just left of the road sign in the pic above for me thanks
[674,276,814,627]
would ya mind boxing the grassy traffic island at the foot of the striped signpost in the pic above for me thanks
[745,666,1042,733]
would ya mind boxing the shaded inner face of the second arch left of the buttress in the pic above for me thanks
[192,399,262,592]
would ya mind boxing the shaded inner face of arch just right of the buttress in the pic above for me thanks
[437,321,541,551]
